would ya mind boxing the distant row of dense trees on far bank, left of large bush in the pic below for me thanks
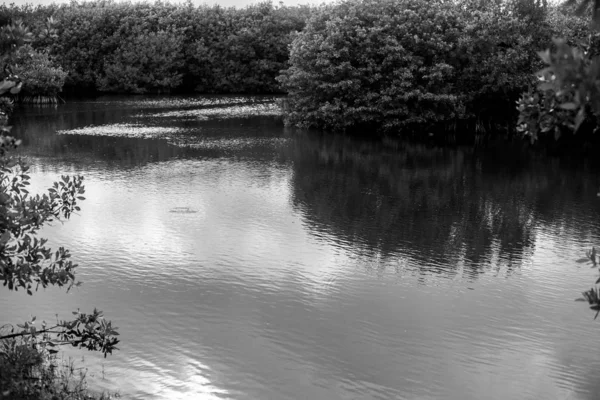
[0,0,311,93]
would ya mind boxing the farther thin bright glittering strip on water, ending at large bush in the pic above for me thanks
[139,102,281,121]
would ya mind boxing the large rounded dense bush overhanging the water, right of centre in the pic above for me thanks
[280,0,582,133]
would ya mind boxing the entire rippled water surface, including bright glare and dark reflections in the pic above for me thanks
[0,97,600,400]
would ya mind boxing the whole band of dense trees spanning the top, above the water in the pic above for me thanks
[0,0,600,141]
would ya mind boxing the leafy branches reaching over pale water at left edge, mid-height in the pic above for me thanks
[0,156,85,294]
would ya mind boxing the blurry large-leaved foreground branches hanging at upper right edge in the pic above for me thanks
[517,5,600,142]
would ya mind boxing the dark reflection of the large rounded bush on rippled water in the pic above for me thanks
[287,134,598,276]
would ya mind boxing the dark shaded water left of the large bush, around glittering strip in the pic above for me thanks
[12,102,288,168]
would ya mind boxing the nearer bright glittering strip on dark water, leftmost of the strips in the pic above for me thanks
[56,124,182,139]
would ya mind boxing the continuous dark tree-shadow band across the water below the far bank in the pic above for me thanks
[14,99,600,278]
